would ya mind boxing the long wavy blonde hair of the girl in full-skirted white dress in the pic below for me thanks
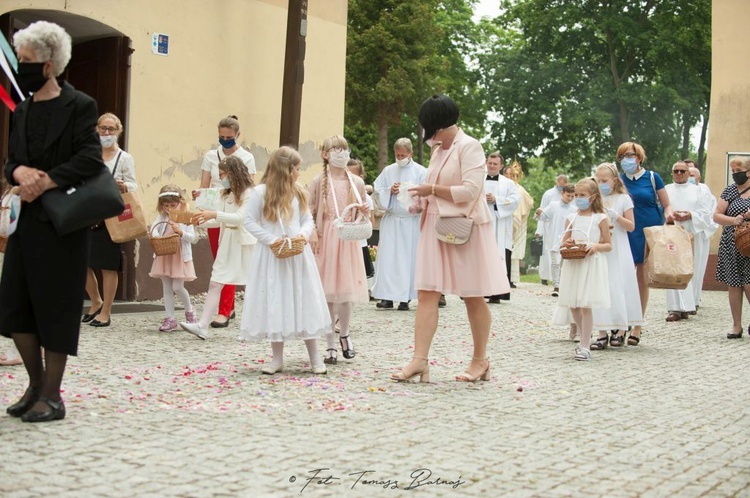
[260,146,308,223]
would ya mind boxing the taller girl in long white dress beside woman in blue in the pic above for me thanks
[591,163,643,349]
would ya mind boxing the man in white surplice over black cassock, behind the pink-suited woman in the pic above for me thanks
[484,152,521,304]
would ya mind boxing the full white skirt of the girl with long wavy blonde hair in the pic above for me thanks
[240,243,331,342]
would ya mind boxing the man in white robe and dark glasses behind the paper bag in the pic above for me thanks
[665,161,713,322]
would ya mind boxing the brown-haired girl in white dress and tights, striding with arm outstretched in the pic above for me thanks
[180,156,257,340]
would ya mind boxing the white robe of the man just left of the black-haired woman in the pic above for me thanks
[372,161,427,302]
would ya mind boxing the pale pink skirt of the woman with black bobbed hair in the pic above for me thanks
[415,212,510,297]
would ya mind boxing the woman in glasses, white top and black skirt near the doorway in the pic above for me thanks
[81,112,138,327]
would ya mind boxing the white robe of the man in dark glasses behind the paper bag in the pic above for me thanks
[665,183,713,311]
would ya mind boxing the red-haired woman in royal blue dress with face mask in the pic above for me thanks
[617,142,672,346]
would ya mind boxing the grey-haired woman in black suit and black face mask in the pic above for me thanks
[0,21,104,422]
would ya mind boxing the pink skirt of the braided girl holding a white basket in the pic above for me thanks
[315,222,370,303]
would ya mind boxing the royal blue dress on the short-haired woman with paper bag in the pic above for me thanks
[620,171,664,264]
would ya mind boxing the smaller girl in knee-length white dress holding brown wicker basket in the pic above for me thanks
[558,178,612,361]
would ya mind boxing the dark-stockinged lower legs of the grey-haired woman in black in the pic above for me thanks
[12,334,68,411]
